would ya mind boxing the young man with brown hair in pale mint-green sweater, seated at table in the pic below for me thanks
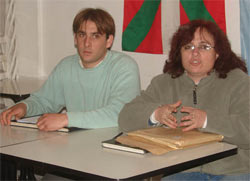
[0,8,140,131]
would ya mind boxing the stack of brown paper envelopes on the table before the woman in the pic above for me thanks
[116,127,223,155]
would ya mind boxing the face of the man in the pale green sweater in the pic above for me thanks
[74,20,114,68]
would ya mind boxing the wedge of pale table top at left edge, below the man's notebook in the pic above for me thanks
[0,124,64,149]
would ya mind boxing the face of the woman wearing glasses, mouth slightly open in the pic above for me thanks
[181,28,219,83]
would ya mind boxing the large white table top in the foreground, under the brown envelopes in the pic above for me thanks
[1,128,236,179]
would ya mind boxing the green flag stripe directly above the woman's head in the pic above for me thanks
[180,0,215,22]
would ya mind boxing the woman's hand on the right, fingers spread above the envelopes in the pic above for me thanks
[180,106,207,131]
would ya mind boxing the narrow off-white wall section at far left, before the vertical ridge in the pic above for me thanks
[16,0,40,77]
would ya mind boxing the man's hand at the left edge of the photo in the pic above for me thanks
[0,103,27,125]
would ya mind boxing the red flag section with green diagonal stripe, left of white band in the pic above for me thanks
[122,0,163,54]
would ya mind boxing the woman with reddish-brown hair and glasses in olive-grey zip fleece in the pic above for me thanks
[119,20,250,180]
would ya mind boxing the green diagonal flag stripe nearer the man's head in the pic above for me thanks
[122,0,161,51]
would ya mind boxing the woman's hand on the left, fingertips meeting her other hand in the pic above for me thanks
[155,101,181,128]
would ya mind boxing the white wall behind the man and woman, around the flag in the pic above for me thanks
[13,0,240,89]
